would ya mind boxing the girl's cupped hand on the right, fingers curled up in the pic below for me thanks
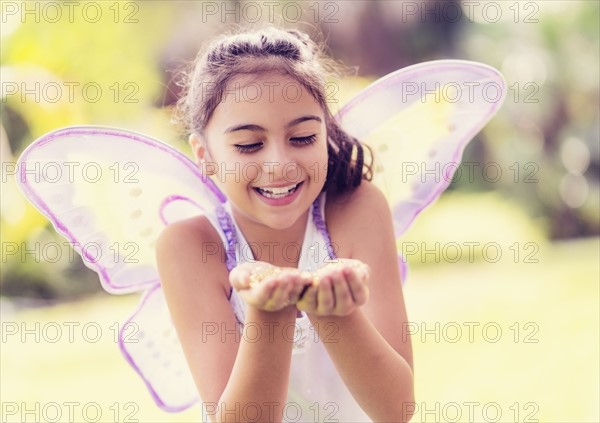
[296,259,370,316]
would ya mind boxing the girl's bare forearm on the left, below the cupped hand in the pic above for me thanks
[217,307,296,422]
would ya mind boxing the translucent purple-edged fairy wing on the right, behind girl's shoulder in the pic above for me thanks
[336,60,506,237]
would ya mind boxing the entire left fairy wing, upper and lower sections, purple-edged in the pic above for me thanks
[16,126,225,411]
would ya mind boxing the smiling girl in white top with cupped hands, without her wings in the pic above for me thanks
[157,28,414,422]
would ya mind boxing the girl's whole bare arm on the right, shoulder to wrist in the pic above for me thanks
[309,181,414,422]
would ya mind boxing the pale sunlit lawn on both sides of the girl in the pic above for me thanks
[0,238,600,422]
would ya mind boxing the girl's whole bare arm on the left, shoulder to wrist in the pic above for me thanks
[157,219,295,421]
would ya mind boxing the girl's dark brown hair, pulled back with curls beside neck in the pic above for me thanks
[176,27,372,192]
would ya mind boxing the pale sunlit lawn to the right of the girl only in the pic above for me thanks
[405,239,600,422]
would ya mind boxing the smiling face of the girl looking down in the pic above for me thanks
[191,73,327,229]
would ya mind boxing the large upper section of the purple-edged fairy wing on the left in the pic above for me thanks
[17,126,224,294]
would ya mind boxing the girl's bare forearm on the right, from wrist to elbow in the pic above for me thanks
[309,308,414,422]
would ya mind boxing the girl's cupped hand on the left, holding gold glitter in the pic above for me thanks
[229,261,313,311]
